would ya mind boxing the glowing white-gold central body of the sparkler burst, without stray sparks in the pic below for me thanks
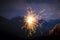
[21,7,39,36]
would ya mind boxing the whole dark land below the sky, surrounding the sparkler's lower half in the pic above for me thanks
[0,16,60,40]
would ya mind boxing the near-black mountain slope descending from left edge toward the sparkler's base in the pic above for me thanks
[0,16,26,39]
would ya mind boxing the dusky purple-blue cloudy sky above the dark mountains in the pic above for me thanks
[0,0,60,20]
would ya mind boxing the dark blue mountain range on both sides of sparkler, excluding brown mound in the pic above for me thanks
[0,16,60,39]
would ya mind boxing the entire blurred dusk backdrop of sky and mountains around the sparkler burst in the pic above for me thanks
[0,0,60,40]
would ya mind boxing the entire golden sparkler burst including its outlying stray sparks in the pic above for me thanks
[22,8,45,37]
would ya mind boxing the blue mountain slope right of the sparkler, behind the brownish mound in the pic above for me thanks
[34,19,60,36]
